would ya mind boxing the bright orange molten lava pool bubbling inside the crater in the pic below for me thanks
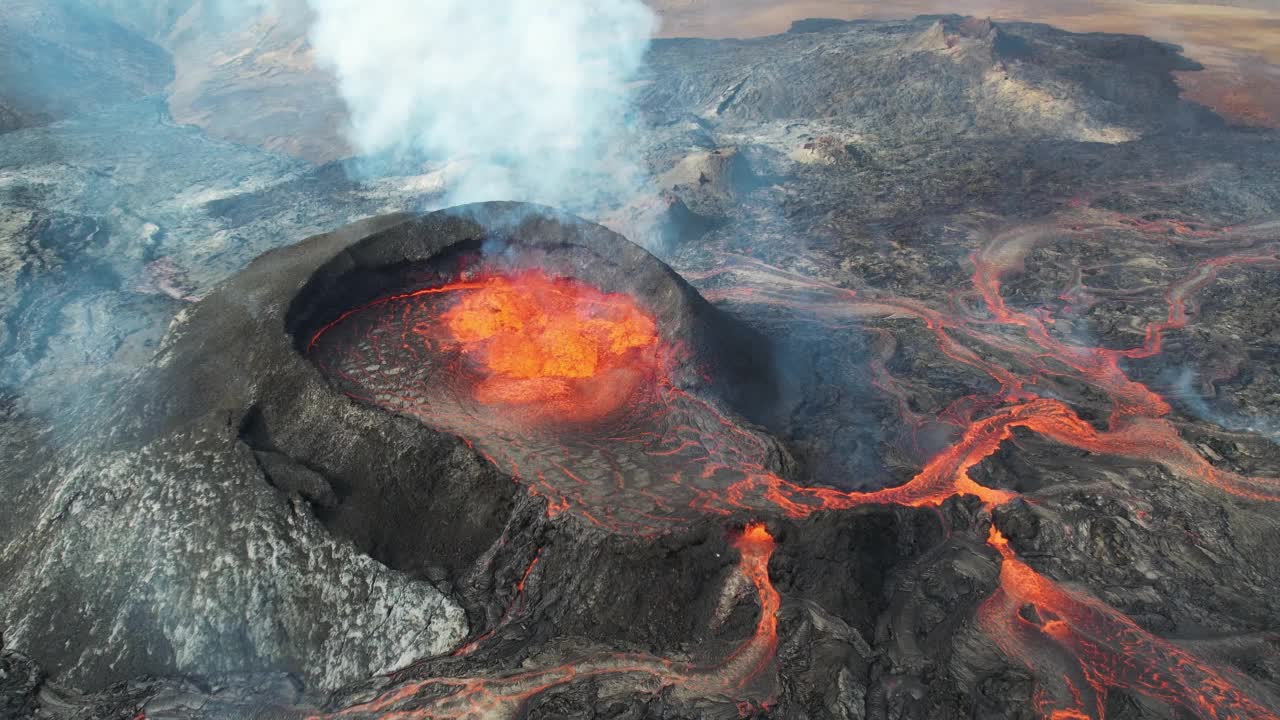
[442,270,658,420]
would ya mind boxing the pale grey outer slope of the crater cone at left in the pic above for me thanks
[0,213,476,687]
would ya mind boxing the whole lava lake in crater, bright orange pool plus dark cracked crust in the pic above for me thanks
[307,263,769,534]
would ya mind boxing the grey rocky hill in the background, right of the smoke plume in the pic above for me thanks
[644,15,1203,142]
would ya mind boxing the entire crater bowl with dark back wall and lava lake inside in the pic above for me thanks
[288,202,785,534]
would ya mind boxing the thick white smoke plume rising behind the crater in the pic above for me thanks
[308,0,655,206]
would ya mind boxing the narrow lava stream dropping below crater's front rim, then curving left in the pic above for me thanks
[307,524,781,720]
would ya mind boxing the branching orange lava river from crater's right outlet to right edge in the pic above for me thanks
[696,251,1280,507]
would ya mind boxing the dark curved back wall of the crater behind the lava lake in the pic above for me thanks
[287,202,776,420]
